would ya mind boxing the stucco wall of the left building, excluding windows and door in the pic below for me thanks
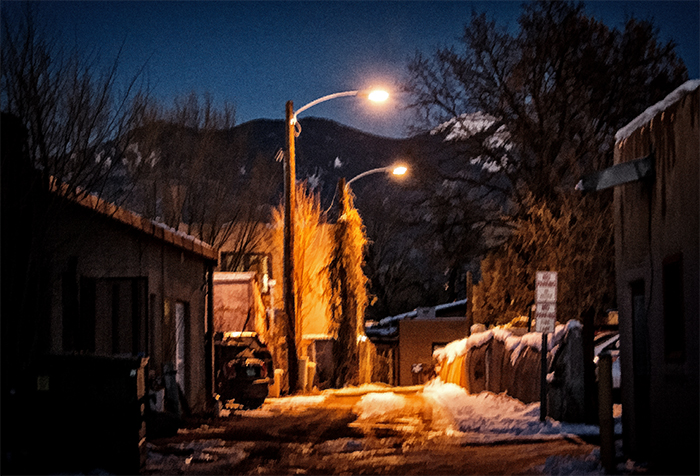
[47,206,212,411]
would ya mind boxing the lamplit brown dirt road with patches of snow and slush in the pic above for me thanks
[143,393,595,475]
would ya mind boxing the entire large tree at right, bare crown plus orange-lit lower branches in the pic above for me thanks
[407,1,687,324]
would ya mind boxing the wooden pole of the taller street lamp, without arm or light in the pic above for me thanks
[283,101,299,393]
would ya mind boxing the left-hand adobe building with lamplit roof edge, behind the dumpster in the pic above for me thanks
[46,186,217,413]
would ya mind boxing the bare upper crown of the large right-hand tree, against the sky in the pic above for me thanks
[407,1,687,203]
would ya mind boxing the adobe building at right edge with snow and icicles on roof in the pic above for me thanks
[612,80,700,474]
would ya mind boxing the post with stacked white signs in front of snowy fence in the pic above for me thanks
[535,271,557,421]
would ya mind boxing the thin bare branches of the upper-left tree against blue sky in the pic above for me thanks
[0,3,146,203]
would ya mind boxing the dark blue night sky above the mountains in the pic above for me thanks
[3,0,700,137]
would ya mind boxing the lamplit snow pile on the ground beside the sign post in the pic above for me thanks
[423,379,600,443]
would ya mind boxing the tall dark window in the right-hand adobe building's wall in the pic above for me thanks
[663,255,685,361]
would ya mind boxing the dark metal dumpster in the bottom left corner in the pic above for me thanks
[33,354,148,474]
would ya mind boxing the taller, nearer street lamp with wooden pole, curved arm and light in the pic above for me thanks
[283,89,389,391]
